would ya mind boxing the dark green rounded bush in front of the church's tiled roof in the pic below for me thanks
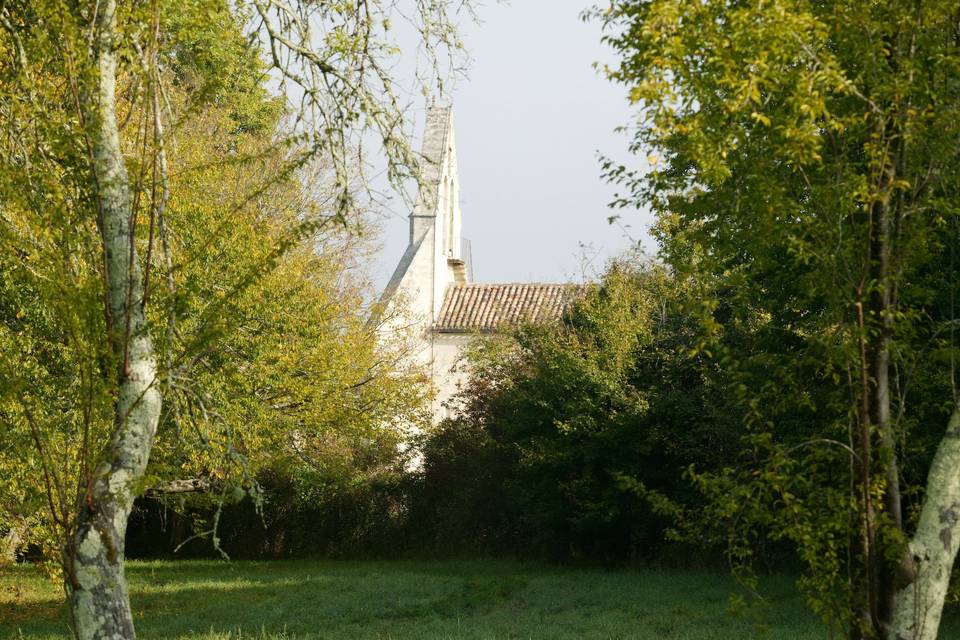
[424,262,739,559]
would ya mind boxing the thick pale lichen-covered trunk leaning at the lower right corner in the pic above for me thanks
[887,406,960,640]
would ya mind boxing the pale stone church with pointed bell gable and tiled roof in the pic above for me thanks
[381,107,582,422]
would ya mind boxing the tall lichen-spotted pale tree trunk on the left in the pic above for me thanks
[63,0,160,640]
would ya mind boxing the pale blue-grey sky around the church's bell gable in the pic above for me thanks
[371,0,653,287]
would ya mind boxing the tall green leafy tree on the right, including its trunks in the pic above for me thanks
[593,0,960,639]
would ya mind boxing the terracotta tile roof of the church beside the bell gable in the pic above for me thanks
[434,283,584,333]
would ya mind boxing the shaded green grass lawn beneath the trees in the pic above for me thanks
[0,560,960,640]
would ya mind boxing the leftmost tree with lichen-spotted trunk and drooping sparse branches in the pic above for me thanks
[0,0,459,638]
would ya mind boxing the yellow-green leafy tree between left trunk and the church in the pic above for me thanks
[135,92,425,553]
